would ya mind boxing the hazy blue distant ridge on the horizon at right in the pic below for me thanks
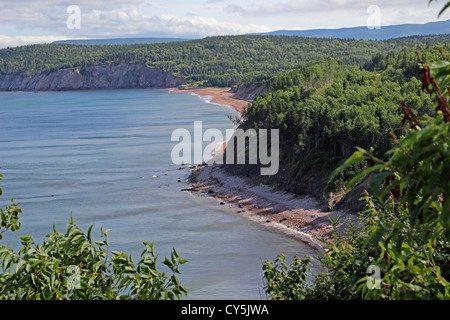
[250,20,450,40]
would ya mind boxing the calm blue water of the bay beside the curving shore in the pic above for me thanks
[0,90,314,299]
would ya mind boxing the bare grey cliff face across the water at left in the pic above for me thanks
[0,64,186,91]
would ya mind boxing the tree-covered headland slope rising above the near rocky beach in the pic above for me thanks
[226,45,450,210]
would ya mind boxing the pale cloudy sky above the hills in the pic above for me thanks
[0,0,450,48]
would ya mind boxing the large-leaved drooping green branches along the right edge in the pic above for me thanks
[344,74,450,299]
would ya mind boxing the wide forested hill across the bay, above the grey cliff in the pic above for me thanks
[0,35,450,87]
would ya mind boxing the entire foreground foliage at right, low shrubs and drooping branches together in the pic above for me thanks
[264,10,450,300]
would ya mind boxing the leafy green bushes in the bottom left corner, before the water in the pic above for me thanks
[0,172,187,300]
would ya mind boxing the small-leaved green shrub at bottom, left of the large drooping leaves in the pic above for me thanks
[263,195,379,300]
